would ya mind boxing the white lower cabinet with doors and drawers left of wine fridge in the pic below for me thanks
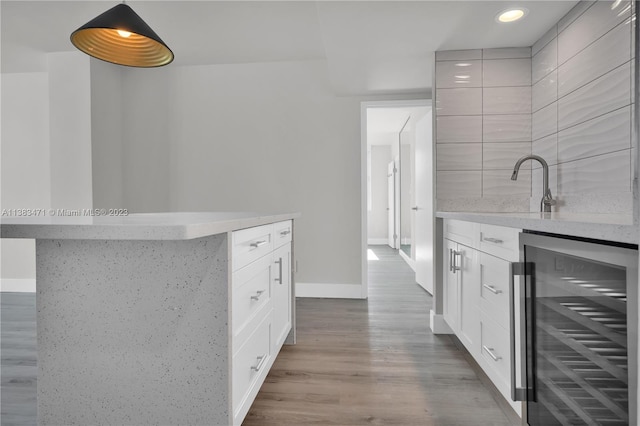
[442,220,520,414]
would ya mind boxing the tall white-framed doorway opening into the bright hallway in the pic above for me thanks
[361,100,434,297]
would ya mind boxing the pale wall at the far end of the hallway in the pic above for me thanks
[367,145,392,244]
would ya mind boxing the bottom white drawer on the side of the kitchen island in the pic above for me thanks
[232,315,272,424]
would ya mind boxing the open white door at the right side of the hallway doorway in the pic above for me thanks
[414,109,434,294]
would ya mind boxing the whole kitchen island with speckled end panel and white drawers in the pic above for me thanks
[1,213,299,425]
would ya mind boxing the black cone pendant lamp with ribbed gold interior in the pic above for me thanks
[71,3,173,68]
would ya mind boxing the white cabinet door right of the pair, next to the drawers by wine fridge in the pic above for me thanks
[457,245,480,357]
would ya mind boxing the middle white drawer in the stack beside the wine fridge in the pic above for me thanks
[480,252,511,329]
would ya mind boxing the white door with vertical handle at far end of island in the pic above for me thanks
[271,243,292,354]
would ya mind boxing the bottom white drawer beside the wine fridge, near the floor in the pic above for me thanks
[480,312,511,397]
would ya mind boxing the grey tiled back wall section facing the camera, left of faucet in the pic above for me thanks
[435,47,532,207]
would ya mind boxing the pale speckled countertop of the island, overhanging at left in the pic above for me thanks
[0,212,300,240]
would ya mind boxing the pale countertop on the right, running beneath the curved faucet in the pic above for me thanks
[436,212,640,244]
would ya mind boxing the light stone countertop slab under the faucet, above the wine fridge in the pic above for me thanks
[436,212,640,244]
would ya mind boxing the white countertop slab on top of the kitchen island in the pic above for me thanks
[0,213,301,240]
